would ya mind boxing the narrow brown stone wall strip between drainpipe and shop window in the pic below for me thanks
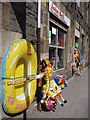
[40,2,49,59]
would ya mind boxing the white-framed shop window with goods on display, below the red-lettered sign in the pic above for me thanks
[49,22,65,70]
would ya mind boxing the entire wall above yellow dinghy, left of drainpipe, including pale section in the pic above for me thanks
[0,2,37,68]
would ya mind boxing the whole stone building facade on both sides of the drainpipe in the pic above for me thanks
[0,1,90,78]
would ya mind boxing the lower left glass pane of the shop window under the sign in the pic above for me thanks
[49,47,55,70]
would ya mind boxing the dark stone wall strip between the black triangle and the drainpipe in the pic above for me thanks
[26,2,38,41]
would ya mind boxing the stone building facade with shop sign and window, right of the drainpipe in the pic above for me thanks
[41,1,89,77]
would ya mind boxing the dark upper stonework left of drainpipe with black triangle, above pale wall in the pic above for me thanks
[2,2,38,41]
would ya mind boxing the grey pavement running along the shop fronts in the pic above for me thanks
[0,67,90,119]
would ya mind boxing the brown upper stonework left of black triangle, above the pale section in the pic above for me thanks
[2,2,21,32]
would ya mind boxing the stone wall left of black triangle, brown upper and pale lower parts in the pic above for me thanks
[0,3,22,66]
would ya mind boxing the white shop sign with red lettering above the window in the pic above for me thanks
[49,1,70,26]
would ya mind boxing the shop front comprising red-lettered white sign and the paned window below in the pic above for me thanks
[49,1,70,75]
